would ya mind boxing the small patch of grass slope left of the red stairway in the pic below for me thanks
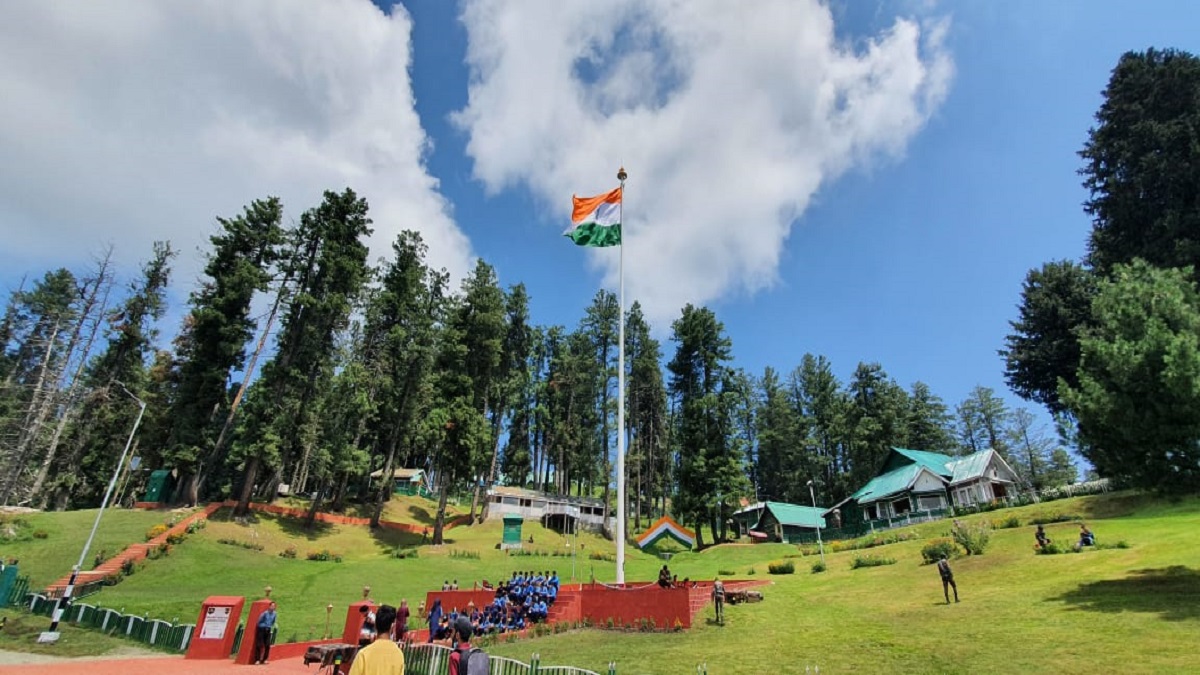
[0,509,190,589]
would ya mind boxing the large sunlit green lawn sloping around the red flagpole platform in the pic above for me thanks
[2,494,1200,675]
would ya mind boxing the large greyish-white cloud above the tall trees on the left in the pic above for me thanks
[0,0,470,288]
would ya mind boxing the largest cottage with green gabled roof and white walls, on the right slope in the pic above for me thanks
[847,448,1018,520]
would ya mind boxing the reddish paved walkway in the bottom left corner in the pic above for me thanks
[0,655,317,675]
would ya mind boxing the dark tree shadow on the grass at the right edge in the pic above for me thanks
[1050,565,1200,621]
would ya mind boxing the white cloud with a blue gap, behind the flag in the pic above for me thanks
[456,0,953,321]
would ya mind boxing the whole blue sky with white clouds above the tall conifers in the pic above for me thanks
[0,0,1200,441]
